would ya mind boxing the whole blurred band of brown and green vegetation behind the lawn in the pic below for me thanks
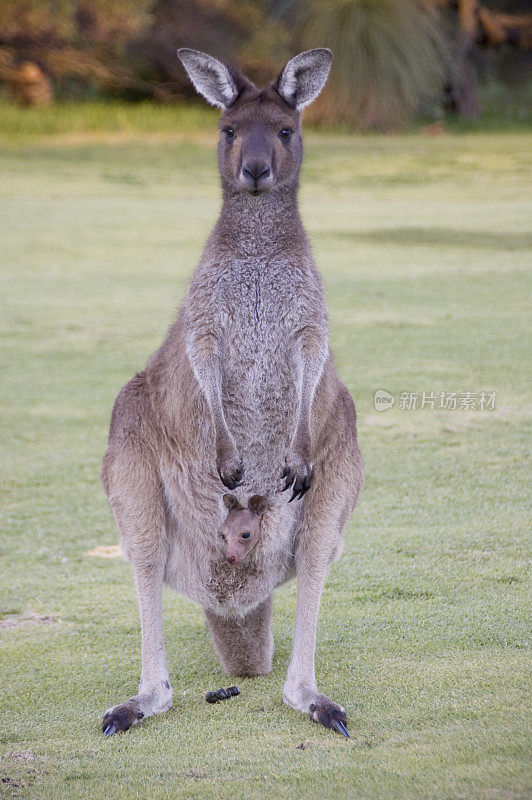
[0,0,532,130]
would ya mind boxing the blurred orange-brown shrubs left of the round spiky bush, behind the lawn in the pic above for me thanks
[0,0,287,100]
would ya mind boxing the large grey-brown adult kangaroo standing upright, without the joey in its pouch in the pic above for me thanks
[102,49,363,736]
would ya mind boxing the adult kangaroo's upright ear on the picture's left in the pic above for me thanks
[177,47,255,109]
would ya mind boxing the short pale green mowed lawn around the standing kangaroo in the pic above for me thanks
[0,108,532,800]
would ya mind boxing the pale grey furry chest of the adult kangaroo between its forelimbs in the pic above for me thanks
[216,260,305,477]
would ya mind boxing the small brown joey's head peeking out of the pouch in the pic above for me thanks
[220,494,268,564]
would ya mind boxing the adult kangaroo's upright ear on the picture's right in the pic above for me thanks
[273,47,332,111]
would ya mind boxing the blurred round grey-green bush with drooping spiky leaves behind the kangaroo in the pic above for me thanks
[285,0,448,128]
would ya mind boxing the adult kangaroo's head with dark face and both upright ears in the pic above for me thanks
[178,48,332,196]
